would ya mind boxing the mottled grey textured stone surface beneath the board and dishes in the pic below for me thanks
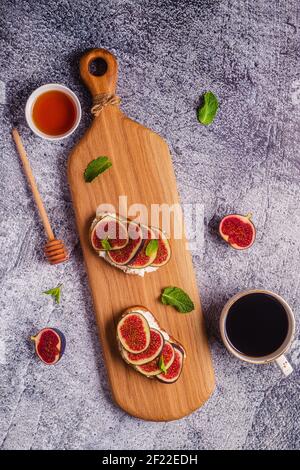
[0,0,300,449]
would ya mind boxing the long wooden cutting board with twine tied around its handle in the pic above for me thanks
[68,49,214,421]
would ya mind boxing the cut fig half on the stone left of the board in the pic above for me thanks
[30,328,66,365]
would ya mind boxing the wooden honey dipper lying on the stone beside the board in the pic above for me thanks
[12,128,68,264]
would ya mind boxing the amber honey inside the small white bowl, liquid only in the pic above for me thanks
[32,90,77,137]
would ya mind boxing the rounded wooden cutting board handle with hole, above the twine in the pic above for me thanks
[79,49,118,97]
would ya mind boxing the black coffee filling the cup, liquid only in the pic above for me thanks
[225,293,289,357]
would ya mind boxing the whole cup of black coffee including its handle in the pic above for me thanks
[220,289,295,376]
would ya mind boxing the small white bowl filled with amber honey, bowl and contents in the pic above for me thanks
[25,83,81,140]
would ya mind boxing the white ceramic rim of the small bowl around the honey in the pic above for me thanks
[25,83,81,141]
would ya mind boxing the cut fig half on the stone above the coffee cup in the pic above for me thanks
[219,214,256,250]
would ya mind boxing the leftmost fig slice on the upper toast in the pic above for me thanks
[91,215,129,251]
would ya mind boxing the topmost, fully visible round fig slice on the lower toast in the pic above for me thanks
[117,312,150,354]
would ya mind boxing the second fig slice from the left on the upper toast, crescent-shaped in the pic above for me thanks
[107,222,142,266]
